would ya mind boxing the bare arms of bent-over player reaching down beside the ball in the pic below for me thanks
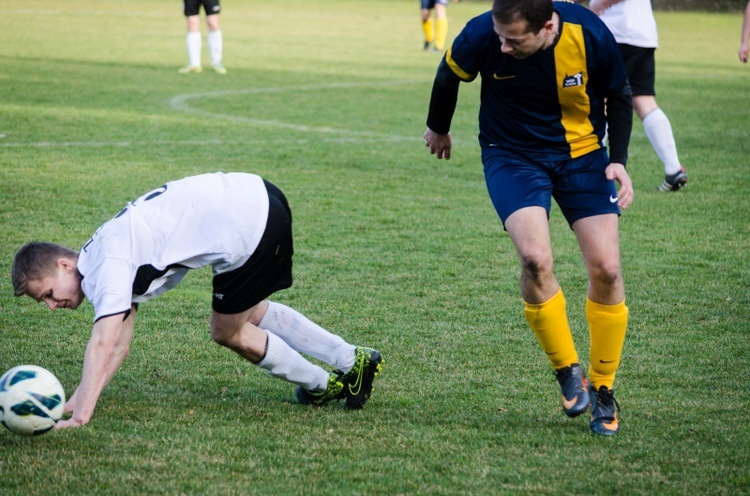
[56,308,135,429]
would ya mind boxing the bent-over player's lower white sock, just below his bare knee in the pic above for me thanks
[257,331,329,391]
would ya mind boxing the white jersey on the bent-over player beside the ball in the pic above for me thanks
[78,172,268,321]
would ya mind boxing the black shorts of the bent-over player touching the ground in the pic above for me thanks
[211,180,294,314]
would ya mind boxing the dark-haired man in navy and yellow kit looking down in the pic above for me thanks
[424,0,633,435]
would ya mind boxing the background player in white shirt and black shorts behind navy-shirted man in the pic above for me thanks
[589,0,687,191]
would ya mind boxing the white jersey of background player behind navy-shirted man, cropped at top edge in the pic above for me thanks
[589,0,659,48]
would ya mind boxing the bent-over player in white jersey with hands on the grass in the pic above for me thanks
[12,173,382,428]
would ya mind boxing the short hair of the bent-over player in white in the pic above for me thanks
[11,241,78,296]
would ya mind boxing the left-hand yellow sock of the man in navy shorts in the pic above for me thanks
[523,289,578,370]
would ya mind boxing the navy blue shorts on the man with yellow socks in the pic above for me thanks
[482,147,620,230]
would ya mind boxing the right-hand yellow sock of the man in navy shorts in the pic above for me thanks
[586,298,628,389]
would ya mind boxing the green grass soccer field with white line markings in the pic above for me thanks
[0,0,750,496]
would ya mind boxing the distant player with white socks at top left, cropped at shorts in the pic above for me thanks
[179,0,227,74]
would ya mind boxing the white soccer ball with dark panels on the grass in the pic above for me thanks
[0,365,65,436]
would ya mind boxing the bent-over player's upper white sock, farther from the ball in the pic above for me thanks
[258,301,355,372]
